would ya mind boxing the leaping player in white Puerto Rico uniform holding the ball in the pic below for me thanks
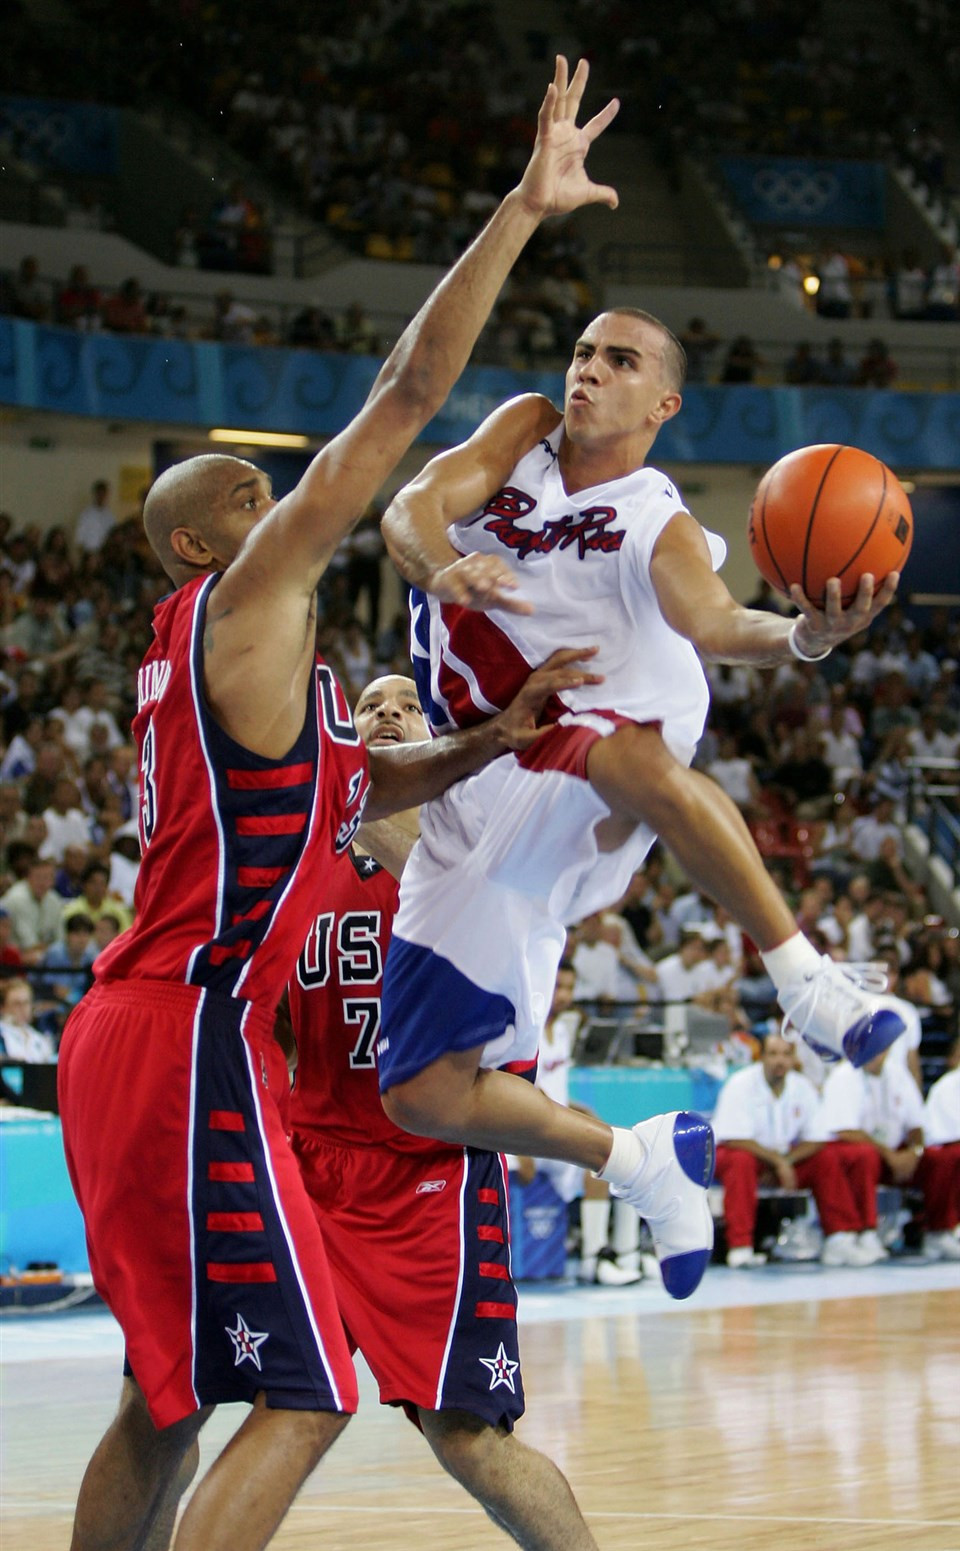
[373,309,903,1297]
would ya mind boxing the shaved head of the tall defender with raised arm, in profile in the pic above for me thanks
[143,453,259,586]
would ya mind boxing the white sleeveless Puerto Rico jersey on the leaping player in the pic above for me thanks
[411,427,726,760]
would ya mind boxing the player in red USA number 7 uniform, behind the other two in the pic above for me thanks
[288,675,596,1551]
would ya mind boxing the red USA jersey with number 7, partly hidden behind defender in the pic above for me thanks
[288,853,437,1152]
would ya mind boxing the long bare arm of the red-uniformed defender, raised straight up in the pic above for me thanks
[205,57,619,757]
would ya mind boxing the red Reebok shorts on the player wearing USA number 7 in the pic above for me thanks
[293,1131,524,1427]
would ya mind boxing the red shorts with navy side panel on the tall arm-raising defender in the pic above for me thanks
[59,980,357,1427]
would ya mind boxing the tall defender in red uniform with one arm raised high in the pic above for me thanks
[59,59,617,1551]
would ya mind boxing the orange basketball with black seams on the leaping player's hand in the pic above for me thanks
[748,444,913,608]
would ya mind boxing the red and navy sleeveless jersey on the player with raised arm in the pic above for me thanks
[95,575,369,1010]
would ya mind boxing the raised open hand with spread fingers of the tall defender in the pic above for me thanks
[520,54,620,216]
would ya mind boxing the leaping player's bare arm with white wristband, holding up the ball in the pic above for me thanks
[650,512,900,667]
